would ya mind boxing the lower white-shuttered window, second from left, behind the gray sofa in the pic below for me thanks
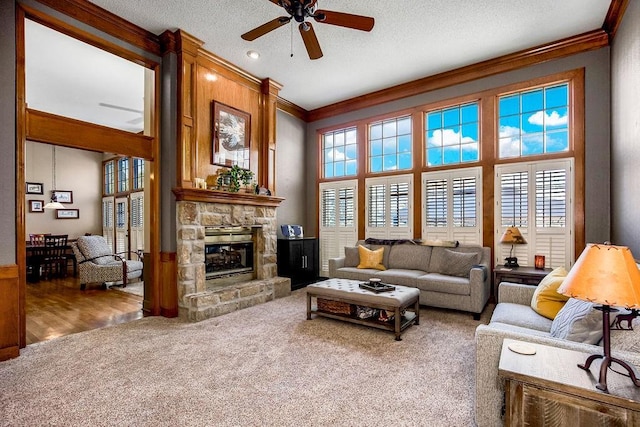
[365,175,413,239]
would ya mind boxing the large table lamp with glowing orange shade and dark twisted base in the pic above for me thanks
[558,242,640,392]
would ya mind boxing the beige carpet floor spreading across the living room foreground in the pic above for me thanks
[0,289,489,426]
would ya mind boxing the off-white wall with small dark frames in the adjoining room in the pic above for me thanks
[25,141,102,240]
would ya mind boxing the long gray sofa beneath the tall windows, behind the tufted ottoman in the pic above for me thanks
[329,240,491,319]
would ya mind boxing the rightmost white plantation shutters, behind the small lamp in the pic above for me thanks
[494,159,575,269]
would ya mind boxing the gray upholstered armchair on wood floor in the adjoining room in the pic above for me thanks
[71,236,142,290]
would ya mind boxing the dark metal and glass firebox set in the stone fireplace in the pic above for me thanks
[204,226,254,279]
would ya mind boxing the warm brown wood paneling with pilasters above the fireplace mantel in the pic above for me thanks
[168,30,281,193]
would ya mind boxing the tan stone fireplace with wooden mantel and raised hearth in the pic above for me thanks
[174,189,291,321]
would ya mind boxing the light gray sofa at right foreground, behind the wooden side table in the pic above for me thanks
[475,282,640,427]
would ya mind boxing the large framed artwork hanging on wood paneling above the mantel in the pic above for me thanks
[211,101,251,169]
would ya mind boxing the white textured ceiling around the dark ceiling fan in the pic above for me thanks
[85,0,610,110]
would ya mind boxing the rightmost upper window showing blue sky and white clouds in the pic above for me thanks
[498,83,570,158]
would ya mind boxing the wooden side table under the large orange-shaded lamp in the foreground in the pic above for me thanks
[498,339,640,427]
